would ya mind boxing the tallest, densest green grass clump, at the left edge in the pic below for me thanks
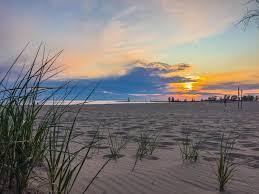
[0,44,61,193]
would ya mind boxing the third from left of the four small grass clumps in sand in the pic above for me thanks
[179,130,200,162]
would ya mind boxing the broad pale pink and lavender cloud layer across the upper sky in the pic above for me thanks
[0,0,252,78]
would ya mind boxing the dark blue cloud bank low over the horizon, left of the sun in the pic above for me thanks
[42,62,192,100]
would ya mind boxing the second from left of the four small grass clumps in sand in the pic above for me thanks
[132,131,159,171]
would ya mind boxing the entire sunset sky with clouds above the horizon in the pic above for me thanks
[0,0,259,100]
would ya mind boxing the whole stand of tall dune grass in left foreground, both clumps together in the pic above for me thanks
[0,45,110,194]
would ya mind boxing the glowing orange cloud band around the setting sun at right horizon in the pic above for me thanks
[168,68,259,99]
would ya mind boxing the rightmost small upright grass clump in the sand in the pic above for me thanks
[216,133,236,192]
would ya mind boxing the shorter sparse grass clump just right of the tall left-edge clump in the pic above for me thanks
[45,110,98,193]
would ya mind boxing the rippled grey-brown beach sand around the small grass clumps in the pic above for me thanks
[43,102,259,194]
